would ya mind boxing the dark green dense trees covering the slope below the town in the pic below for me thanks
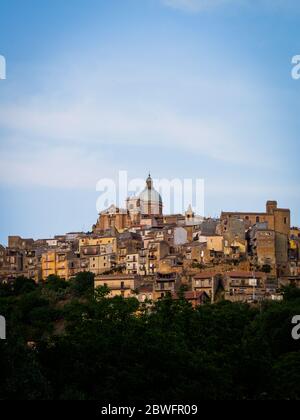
[0,273,300,403]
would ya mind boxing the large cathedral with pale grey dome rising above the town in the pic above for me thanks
[93,174,163,233]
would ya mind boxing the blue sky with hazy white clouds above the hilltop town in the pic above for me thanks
[0,0,300,244]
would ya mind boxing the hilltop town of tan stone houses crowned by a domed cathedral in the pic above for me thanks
[0,175,300,305]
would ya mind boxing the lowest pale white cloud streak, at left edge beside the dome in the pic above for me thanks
[0,147,116,190]
